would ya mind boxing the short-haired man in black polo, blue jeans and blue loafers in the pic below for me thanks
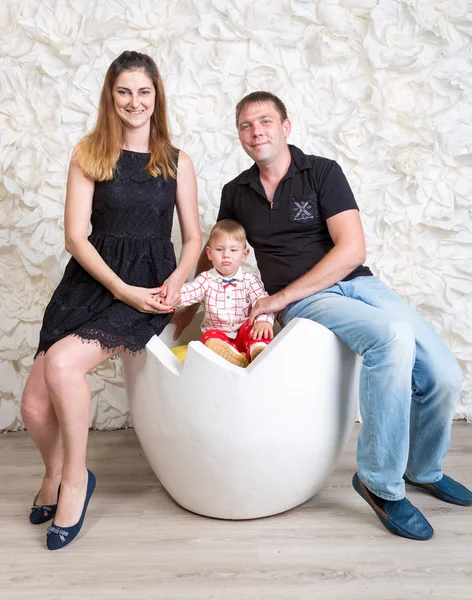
[176,92,472,540]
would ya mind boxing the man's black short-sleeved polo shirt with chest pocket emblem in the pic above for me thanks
[217,146,372,294]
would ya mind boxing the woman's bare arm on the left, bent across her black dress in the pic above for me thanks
[64,158,166,313]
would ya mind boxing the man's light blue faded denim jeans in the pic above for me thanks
[279,277,462,500]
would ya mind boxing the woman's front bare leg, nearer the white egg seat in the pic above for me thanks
[44,336,116,527]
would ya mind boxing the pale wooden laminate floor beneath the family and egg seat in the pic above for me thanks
[0,422,472,600]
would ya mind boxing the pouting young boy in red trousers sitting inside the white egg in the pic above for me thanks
[179,219,274,367]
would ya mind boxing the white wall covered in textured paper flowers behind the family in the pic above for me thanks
[0,0,472,430]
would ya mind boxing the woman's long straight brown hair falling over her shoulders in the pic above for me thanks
[74,50,177,181]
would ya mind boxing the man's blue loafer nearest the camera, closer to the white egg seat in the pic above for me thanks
[352,473,434,540]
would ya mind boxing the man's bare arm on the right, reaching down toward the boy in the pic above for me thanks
[251,209,365,318]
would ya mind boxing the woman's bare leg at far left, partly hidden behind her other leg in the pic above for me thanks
[21,355,63,504]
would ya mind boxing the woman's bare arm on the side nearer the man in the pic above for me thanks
[160,150,202,306]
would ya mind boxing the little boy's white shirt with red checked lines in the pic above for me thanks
[179,267,274,338]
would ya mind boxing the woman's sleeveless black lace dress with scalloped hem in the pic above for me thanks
[36,150,176,356]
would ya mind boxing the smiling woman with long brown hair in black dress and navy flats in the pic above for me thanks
[22,52,201,550]
